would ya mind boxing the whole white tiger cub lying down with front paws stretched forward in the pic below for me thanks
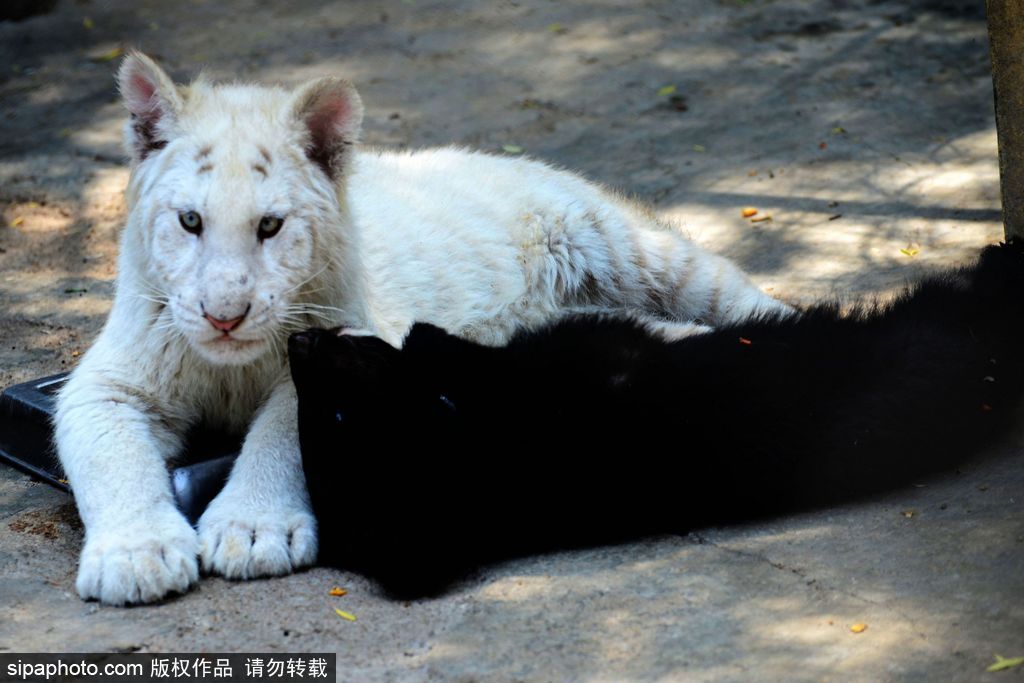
[55,53,788,604]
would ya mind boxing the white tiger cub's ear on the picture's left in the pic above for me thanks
[118,50,183,164]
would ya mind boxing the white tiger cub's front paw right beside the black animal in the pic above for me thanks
[199,499,316,579]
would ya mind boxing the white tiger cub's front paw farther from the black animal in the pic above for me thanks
[75,508,199,605]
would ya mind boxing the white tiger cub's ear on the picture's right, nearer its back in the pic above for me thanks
[292,78,362,179]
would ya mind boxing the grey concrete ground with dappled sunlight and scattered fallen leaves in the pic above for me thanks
[0,0,1024,681]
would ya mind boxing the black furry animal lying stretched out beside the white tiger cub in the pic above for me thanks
[290,243,1024,596]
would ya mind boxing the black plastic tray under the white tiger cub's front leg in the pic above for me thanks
[0,374,241,524]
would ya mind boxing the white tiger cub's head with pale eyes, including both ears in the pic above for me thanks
[120,53,361,365]
